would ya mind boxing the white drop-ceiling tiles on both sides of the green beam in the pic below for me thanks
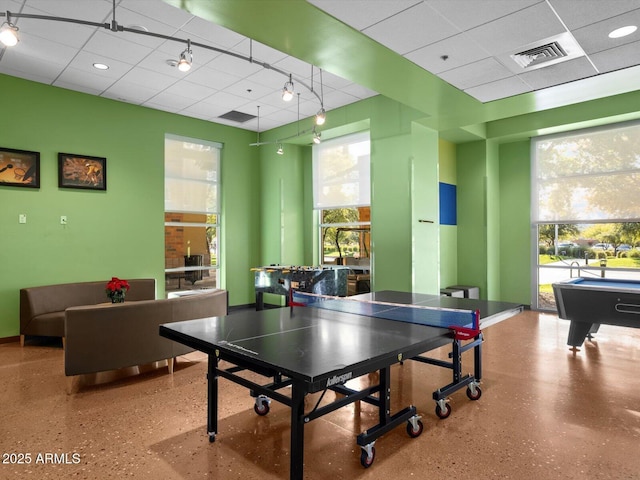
[0,0,640,130]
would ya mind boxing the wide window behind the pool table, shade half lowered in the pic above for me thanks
[531,123,640,310]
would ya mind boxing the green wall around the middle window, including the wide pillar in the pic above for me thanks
[261,96,438,293]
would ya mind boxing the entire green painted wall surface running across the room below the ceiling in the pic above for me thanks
[0,56,640,338]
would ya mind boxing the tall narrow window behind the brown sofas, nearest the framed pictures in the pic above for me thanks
[165,135,222,292]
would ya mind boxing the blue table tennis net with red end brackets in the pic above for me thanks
[289,290,480,340]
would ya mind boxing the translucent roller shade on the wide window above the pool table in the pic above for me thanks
[531,122,640,223]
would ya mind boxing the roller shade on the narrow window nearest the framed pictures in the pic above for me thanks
[164,135,222,213]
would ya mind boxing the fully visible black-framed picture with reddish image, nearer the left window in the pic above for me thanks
[58,153,107,190]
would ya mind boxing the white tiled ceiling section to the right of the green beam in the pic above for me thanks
[308,0,640,102]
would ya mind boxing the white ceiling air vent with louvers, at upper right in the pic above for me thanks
[496,32,584,75]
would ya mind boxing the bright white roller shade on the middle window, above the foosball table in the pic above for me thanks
[313,132,371,209]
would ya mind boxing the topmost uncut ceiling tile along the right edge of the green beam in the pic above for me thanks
[363,3,458,54]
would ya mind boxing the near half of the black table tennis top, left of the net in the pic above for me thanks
[160,291,524,391]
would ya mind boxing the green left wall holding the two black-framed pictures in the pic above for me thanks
[0,75,261,338]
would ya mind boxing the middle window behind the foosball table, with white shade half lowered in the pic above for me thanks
[313,132,371,286]
